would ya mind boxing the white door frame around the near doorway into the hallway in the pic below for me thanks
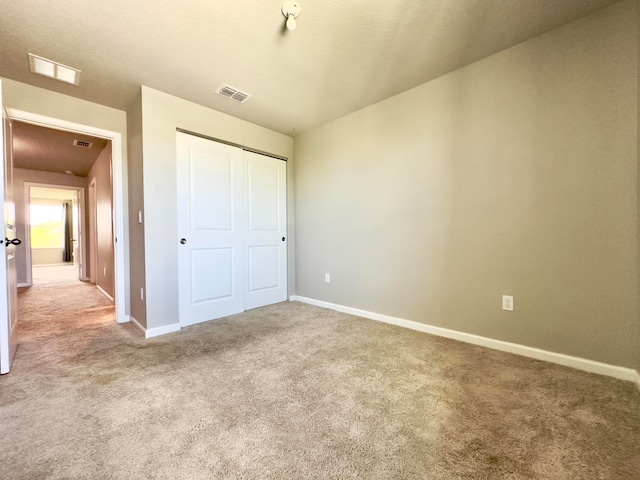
[7,108,129,323]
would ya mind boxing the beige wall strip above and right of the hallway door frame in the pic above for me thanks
[2,78,130,315]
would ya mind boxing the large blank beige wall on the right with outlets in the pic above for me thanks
[295,2,639,367]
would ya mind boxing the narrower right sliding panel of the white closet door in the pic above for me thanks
[244,151,287,310]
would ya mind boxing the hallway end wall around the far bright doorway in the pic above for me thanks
[13,168,87,285]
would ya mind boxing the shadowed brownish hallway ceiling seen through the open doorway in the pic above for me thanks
[12,121,107,177]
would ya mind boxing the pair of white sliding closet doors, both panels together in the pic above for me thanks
[177,133,287,326]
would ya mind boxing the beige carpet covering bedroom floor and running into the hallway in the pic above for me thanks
[0,284,640,479]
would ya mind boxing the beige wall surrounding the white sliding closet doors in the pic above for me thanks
[139,86,295,328]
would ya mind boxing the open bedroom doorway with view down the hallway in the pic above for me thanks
[13,126,115,302]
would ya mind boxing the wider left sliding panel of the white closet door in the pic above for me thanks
[177,133,246,326]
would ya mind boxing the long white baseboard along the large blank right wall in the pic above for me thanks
[290,295,640,389]
